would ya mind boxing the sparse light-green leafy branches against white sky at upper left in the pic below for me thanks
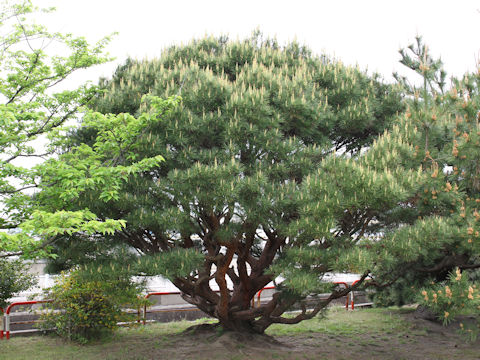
[0,0,109,254]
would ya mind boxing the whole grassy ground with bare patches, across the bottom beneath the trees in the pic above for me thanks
[0,308,480,360]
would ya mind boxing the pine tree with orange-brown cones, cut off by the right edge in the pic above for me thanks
[360,37,480,322]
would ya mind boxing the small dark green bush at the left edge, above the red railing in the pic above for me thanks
[0,258,36,310]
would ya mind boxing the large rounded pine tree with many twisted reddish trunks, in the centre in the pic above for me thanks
[57,35,404,332]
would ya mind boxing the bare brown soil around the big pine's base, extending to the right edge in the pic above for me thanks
[100,313,480,360]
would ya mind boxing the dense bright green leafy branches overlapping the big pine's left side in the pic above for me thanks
[0,93,180,256]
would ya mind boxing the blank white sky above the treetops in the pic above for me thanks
[39,0,480,86]
